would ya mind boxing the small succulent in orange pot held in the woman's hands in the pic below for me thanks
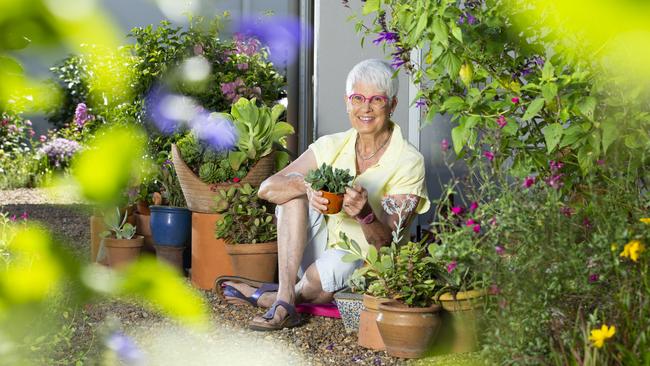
[305,163,353,215]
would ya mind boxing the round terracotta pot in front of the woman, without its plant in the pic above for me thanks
[377,300,442,358]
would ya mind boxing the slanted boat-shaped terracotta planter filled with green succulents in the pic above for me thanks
[171,98,294,213]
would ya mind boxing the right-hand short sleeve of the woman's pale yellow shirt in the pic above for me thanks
[386,153,431,214]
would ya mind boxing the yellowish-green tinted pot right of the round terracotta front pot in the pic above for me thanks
[435,290,486,354]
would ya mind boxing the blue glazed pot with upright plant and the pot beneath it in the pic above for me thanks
[149,160,192,272]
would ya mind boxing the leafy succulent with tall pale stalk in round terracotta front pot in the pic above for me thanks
[337,198,441,358]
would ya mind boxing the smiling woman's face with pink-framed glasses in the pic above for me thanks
[345,82,397,135]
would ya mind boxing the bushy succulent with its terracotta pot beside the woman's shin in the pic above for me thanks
[215,184,278,282]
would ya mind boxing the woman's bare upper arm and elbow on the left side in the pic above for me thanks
[257,150,317,205]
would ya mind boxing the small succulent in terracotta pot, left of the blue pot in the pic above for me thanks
[97,207,144,267]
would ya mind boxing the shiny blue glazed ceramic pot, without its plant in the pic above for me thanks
[149,206,192,246]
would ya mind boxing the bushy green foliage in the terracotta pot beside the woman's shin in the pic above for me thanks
[215,184,277,244]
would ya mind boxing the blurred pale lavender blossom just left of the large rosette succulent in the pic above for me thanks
[190,112,238,151]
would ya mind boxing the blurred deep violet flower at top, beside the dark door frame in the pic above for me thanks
[235,16,312,66]
